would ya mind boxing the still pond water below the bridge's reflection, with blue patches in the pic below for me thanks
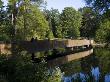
[56,48,110,82]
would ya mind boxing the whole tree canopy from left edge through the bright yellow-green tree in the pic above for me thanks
[0,0,49,40]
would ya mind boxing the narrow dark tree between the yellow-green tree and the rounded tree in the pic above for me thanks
[44,8,60,38]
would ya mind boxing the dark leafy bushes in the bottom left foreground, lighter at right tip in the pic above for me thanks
[0,53,61,82]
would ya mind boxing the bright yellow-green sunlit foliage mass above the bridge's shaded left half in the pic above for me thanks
[16,6,49,39]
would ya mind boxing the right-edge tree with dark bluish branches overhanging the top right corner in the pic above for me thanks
[85,0,110,43]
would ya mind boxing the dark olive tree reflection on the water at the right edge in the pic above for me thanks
[94,48,110,75]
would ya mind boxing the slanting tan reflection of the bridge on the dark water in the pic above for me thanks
[48,49,93,67]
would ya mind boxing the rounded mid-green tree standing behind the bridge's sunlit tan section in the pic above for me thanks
[60,7,82,38]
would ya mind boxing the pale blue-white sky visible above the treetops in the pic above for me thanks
[2,0,85,12]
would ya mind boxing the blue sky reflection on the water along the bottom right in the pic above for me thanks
[62,67,110,82]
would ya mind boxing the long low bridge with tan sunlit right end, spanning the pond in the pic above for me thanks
[0,39,93,54]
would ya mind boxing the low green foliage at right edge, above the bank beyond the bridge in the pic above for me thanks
[96,19,110,42]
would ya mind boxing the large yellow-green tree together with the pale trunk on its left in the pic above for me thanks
[6,0,49,40]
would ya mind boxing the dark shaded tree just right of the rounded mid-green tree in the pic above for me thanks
[79,7,100,38]
